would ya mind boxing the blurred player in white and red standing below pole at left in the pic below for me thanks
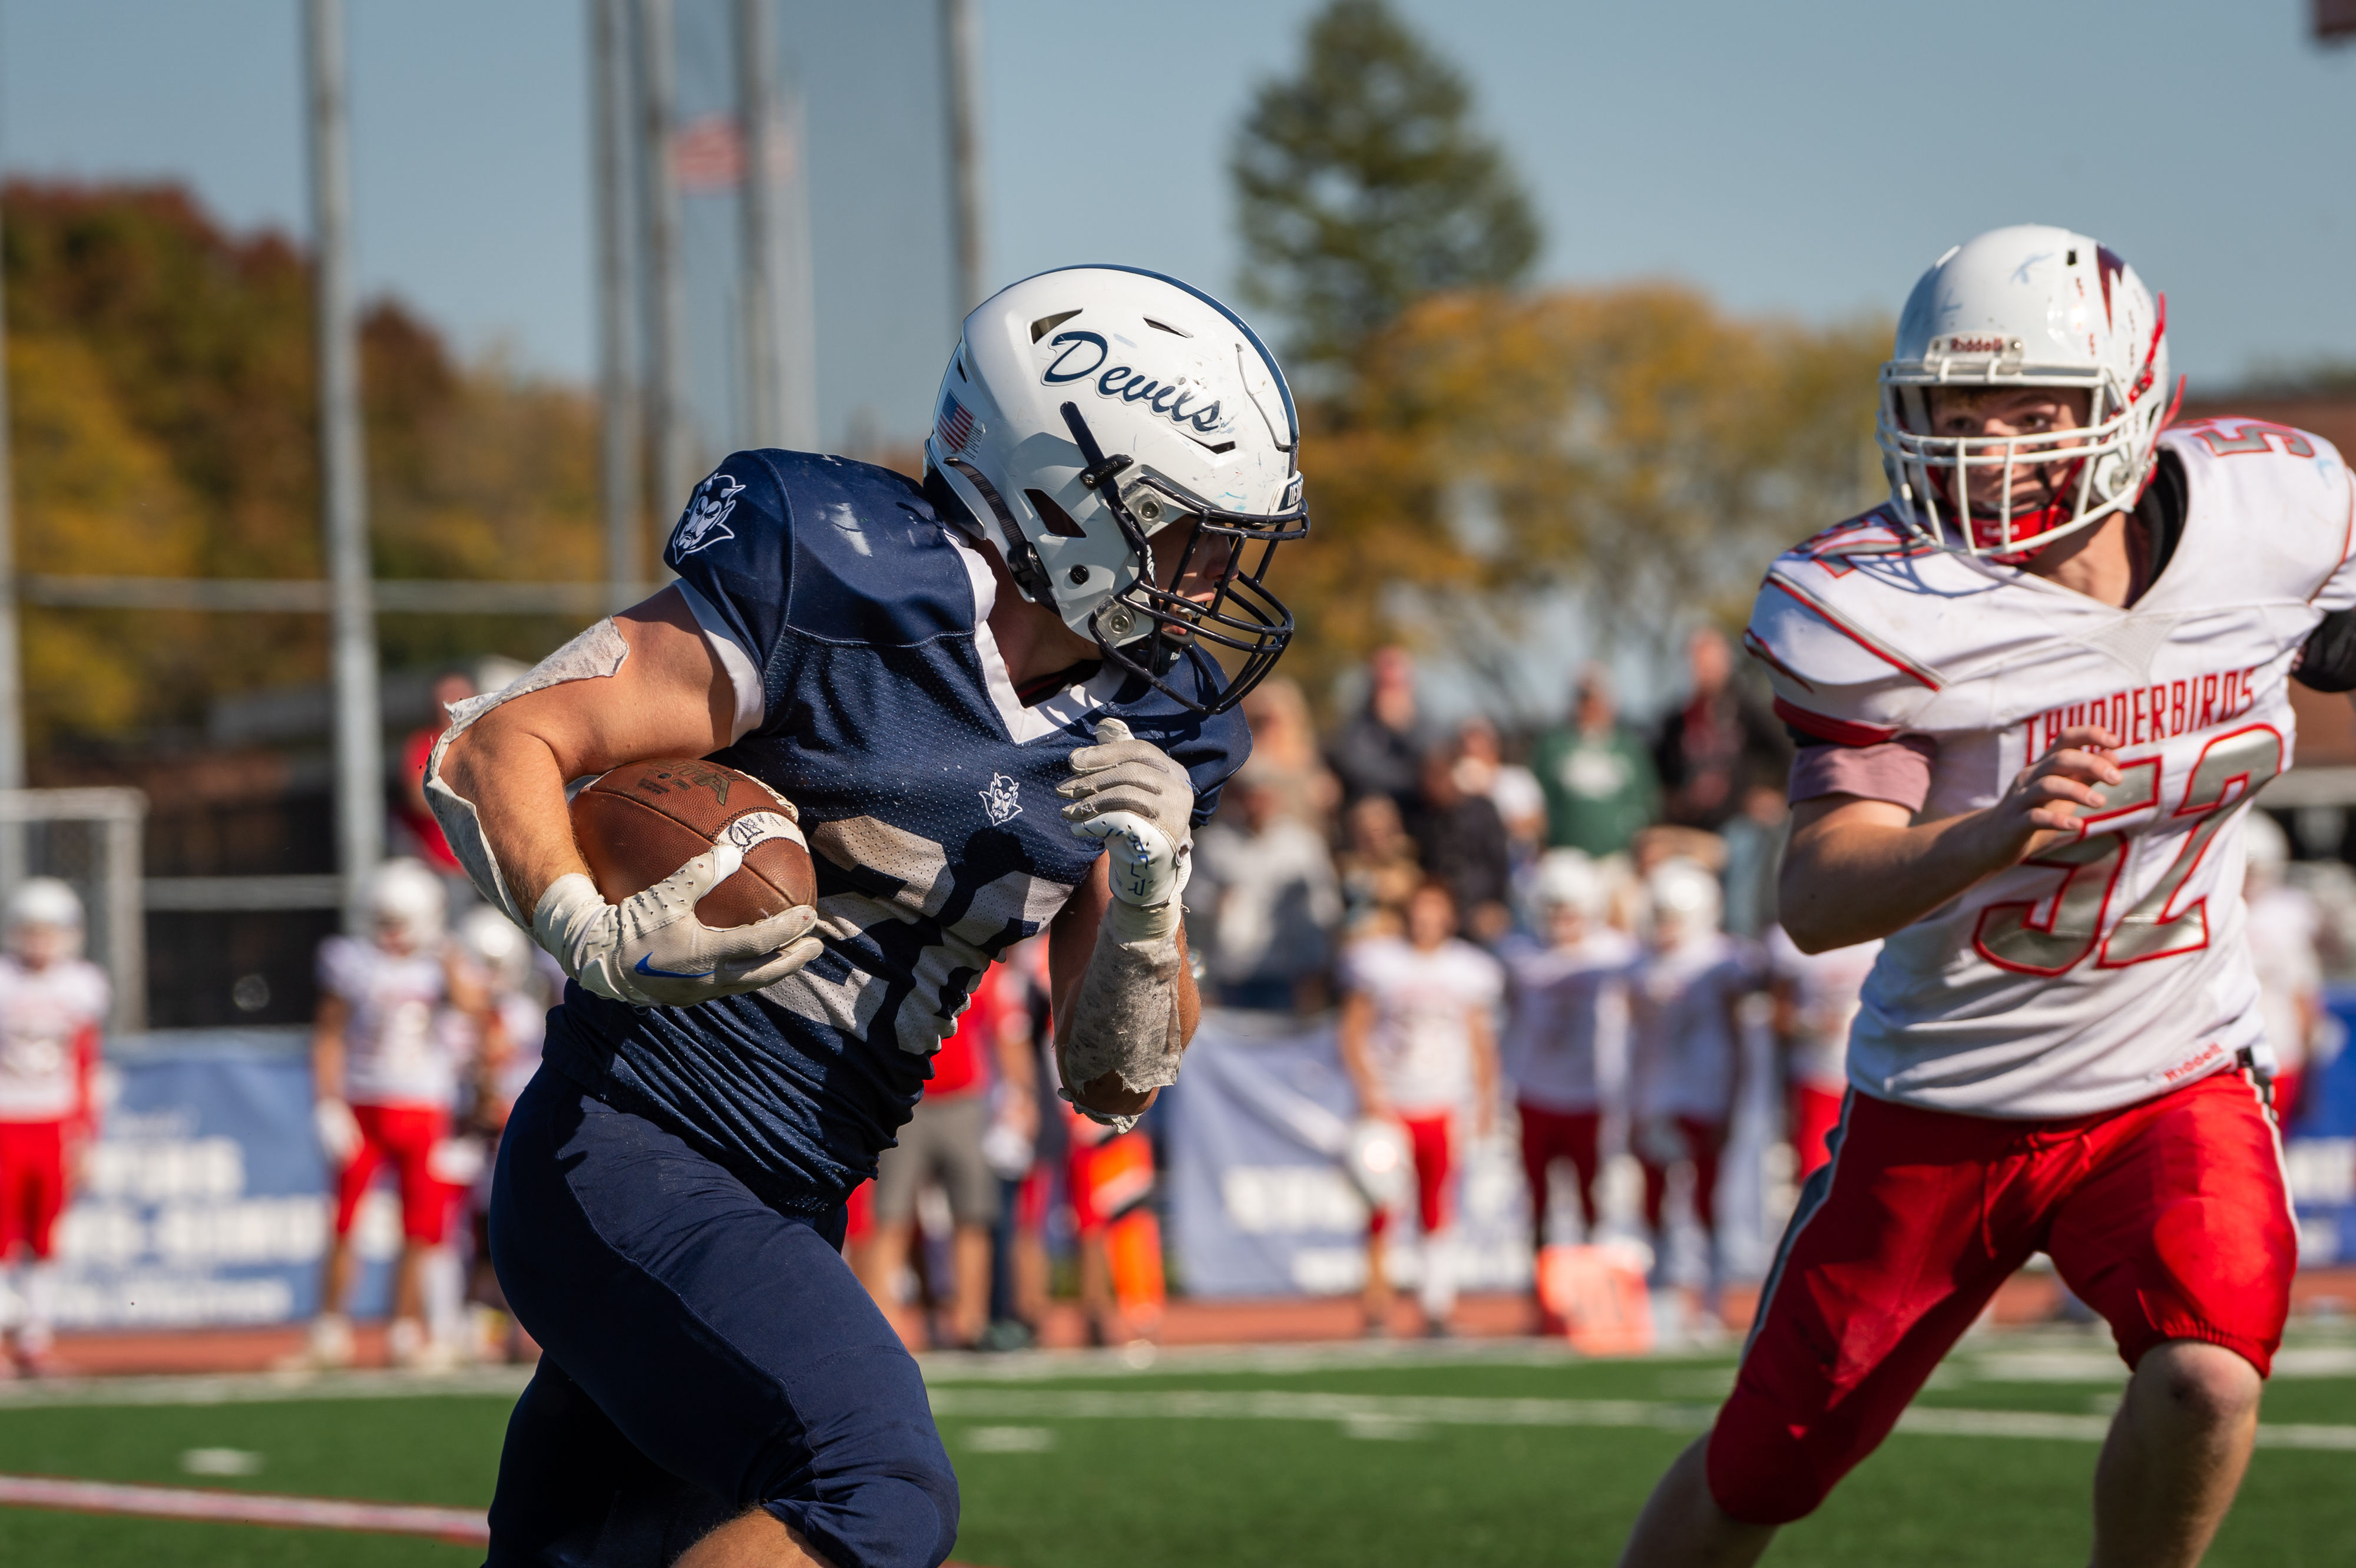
[309,859,485,1365]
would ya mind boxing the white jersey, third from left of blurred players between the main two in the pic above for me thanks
[1628,930,1760,1121]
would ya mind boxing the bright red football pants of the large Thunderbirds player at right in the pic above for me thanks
[1708,1074,2297,1523]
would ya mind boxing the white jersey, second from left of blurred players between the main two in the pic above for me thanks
[1503,928,1637,1112]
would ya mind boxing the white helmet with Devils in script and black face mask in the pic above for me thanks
[924,266,1310,713]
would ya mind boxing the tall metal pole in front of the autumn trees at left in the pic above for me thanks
[304,0,384,932]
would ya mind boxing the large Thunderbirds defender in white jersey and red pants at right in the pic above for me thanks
[1626,226,2356,1568]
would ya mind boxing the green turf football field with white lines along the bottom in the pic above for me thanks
[0,1335,2356,1568]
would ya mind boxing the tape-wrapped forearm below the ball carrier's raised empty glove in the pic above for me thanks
[1055,899,1185,1130]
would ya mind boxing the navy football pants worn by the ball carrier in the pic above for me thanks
[490,1067,957,1568]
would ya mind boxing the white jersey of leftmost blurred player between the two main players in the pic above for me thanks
[1341,937,1505,1116]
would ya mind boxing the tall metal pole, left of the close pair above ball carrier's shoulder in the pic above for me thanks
[589,0,646,610]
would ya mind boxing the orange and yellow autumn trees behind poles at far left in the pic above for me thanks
[0,181,598,777]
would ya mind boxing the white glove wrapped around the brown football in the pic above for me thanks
[532,843,825,1008]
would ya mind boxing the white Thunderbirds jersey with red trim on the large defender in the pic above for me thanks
[1746,419,2356,1119]
